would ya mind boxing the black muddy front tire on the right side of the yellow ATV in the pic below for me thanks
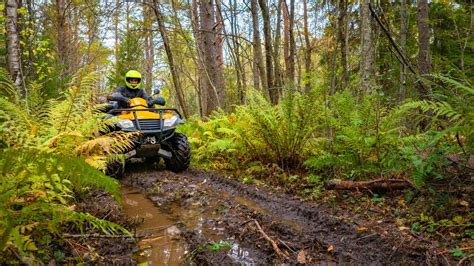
[165,133,191,172]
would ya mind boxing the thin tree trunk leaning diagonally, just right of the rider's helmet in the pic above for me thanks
[153,0,188,117]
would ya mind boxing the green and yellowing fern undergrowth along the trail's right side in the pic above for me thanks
[181,75,474,244]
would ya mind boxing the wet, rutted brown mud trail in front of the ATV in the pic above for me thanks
[121,165,429,265]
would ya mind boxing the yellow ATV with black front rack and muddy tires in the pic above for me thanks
[106,97,191,177]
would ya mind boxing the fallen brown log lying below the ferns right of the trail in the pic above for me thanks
[326,178,411,190]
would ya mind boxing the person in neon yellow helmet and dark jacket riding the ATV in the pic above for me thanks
[107,70,154,108]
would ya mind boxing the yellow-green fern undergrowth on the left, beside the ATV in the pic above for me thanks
[0,67,131,264]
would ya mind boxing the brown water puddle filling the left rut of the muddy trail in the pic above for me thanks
[121,185,254,265]
